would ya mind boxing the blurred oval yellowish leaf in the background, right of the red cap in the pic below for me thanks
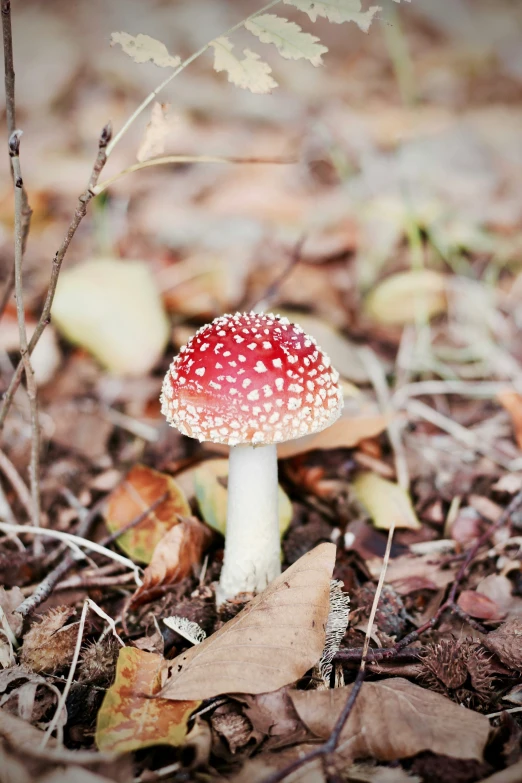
[365,269,446,326]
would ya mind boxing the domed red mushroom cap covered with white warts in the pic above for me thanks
[161,313,343,446]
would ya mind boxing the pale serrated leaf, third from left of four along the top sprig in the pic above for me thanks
[245,14,328,65]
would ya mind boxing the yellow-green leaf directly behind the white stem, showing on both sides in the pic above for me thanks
[193,459,292,536]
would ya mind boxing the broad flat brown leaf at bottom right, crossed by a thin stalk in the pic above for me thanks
[290,677,489,761]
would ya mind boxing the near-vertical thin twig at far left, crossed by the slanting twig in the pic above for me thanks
[9,130,42,555]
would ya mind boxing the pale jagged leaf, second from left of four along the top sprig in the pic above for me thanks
[210,36,277,94]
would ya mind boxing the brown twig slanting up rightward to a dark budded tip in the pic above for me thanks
[0,123,111,430]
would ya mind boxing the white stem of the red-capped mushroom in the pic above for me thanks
[217,445,281,605]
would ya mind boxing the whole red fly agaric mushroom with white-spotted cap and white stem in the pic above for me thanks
[161,313,343,603]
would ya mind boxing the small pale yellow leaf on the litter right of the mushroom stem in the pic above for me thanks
[352,472,421,530]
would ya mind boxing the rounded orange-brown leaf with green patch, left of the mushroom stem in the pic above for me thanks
[105,465,190,563]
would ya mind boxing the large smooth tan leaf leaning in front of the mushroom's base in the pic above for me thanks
[161,544,335,699]
